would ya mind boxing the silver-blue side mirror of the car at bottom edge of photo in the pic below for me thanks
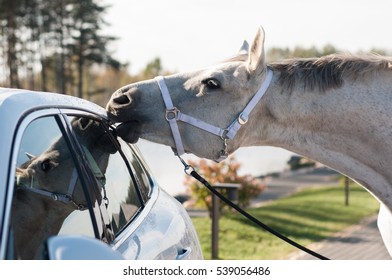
[45,235,124,260]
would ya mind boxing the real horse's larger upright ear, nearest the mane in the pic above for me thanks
[248,26,265,74]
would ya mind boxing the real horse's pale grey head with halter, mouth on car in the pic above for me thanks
[107,28,267,160]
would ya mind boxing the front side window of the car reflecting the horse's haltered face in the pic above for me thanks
[11,116,94,259]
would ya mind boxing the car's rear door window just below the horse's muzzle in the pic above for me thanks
[69,116,143,234]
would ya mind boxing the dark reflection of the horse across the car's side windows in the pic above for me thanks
[12,118,116,259]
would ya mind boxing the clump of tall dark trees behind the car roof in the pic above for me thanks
[0,0,122,97]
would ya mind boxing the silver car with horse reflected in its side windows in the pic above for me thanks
[0,88,203,260]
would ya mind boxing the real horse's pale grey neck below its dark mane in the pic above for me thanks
[250,75,392,210]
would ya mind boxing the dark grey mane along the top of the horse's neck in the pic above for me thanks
[269,54,392,92]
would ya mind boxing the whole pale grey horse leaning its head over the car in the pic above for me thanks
[107,28,392,255]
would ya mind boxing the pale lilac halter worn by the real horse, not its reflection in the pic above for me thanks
[155,70,273,162]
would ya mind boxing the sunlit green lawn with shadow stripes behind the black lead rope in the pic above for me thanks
[192,184,379,260]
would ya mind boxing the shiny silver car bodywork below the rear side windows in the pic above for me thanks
[114,189,203,259]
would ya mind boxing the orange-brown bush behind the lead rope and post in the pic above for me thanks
[184,157,266,216]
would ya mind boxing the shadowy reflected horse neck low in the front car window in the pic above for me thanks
[12,193,72,259]
